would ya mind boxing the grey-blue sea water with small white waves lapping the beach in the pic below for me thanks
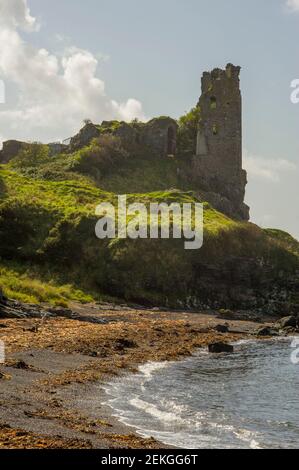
[105,338,299,449]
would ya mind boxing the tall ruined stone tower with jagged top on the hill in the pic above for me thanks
[192,64,249,220]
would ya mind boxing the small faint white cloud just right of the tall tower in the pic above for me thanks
[243,150,297,183]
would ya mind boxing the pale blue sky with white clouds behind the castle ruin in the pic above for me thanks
[0,0,299,238]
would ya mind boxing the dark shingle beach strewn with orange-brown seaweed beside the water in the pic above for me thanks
[0,305,290,449]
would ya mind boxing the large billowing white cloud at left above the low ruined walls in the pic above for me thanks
[0,0,145,144]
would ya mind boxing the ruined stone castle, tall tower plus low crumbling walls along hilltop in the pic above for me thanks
[0,64,249,221]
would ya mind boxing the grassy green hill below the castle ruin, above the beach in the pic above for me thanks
[0,138,299,313]
